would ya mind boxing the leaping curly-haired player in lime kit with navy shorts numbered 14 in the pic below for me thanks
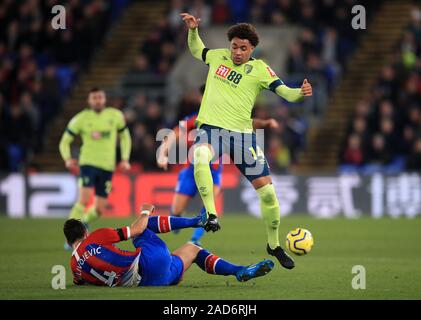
[181,13,312,269]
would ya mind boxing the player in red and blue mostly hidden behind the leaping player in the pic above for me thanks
[157,85,278,245]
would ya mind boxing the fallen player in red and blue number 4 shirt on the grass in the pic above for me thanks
[63,205,274,287]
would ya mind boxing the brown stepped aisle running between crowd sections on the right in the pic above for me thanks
[296,1,414,173]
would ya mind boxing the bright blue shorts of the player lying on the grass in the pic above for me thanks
[133,229,184,286]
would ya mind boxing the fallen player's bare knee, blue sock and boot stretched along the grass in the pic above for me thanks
[172,243,274,281]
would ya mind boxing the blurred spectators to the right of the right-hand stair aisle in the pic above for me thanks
[340,7,421,174]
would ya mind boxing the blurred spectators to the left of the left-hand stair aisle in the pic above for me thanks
[0,0,126,171]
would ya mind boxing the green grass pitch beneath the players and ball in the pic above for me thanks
[0,214,421,300]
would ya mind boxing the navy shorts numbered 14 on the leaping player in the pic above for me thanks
[195,124,270,182]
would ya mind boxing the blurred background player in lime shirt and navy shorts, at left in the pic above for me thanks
[60,88,131,250]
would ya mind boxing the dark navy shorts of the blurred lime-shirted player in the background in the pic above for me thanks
[79,166,113,198]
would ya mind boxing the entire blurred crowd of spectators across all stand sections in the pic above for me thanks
[5,0,410,172]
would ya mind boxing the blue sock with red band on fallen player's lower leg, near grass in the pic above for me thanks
[194,249,244,276]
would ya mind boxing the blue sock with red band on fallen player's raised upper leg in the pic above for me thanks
[148,216,200,233]
